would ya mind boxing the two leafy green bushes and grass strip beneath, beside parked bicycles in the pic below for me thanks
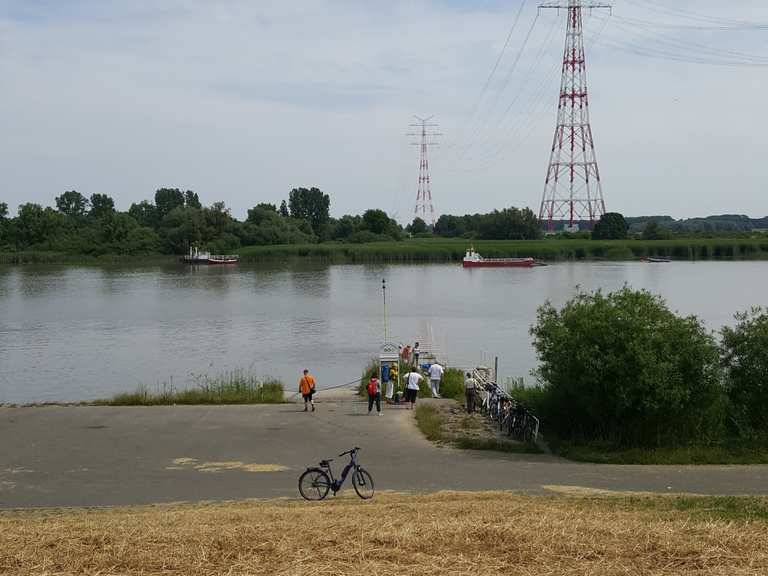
[528,288,768,464]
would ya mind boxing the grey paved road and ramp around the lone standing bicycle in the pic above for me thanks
[0,392,768,509]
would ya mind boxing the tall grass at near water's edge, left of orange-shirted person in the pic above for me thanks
[96,370,285,406]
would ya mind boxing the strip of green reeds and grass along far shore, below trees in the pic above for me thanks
[9,236,768,264]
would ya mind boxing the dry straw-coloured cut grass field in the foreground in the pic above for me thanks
[0,487,768,576]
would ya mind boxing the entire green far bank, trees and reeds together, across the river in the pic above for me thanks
[0,188,768,264]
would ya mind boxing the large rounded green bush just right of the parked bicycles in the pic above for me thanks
[531,288,724,447]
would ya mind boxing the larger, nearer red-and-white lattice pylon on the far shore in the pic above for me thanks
[539,0,611,230]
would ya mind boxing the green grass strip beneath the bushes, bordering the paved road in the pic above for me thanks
[550,440,768,465]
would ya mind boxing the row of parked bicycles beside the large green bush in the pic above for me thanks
[473,368,539,443]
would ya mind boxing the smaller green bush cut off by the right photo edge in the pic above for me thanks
[721,308,768,435]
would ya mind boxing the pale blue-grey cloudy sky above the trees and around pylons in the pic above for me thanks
[0,0,768,223]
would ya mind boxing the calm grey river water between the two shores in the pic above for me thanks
[0,262,768,403]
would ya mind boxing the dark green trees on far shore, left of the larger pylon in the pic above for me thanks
[0,187,541,255]
